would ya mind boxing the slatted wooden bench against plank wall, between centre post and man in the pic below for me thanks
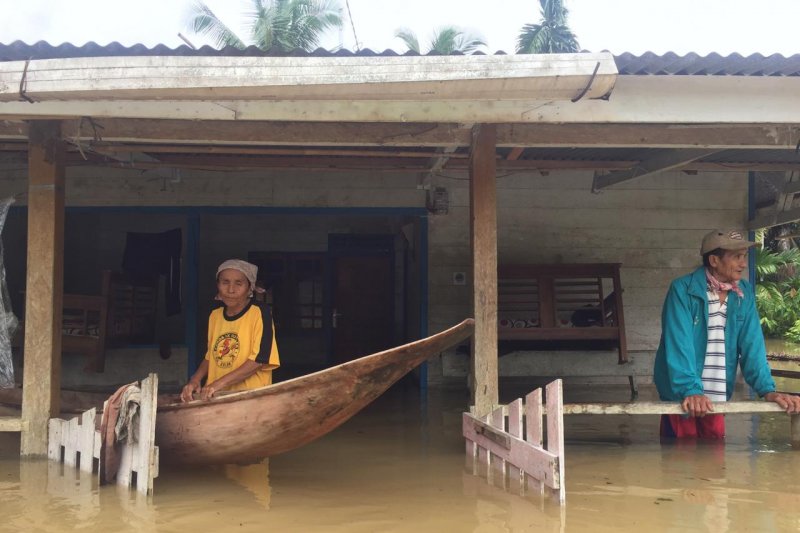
[497,263,628,364]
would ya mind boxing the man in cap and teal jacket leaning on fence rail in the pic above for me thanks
[653,230,800,439]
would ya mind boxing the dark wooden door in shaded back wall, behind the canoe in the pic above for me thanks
[332,255,394,364]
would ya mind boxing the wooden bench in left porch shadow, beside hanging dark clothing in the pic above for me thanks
[18,270,158,372]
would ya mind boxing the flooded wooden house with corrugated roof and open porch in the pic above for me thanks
[0,42,800,504]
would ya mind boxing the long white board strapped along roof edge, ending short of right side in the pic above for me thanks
[0,52,617,102]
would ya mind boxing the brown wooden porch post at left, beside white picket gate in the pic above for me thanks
[20,121,64,457]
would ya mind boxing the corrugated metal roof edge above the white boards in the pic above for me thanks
[0,41,800,76]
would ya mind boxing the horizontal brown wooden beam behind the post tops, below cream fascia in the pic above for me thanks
[6,118,800,149]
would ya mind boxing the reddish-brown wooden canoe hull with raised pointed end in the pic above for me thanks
[156,319,474,464]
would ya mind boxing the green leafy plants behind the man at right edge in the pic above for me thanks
[755,247,800,342]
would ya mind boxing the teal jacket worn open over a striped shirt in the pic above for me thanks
[653,267,775,402]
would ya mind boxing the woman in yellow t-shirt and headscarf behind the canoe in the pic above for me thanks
[181,259,280,402]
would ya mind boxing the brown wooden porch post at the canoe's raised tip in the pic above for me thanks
[469,124,499,417]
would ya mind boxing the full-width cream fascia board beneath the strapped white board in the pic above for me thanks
[0,61,800,125]
